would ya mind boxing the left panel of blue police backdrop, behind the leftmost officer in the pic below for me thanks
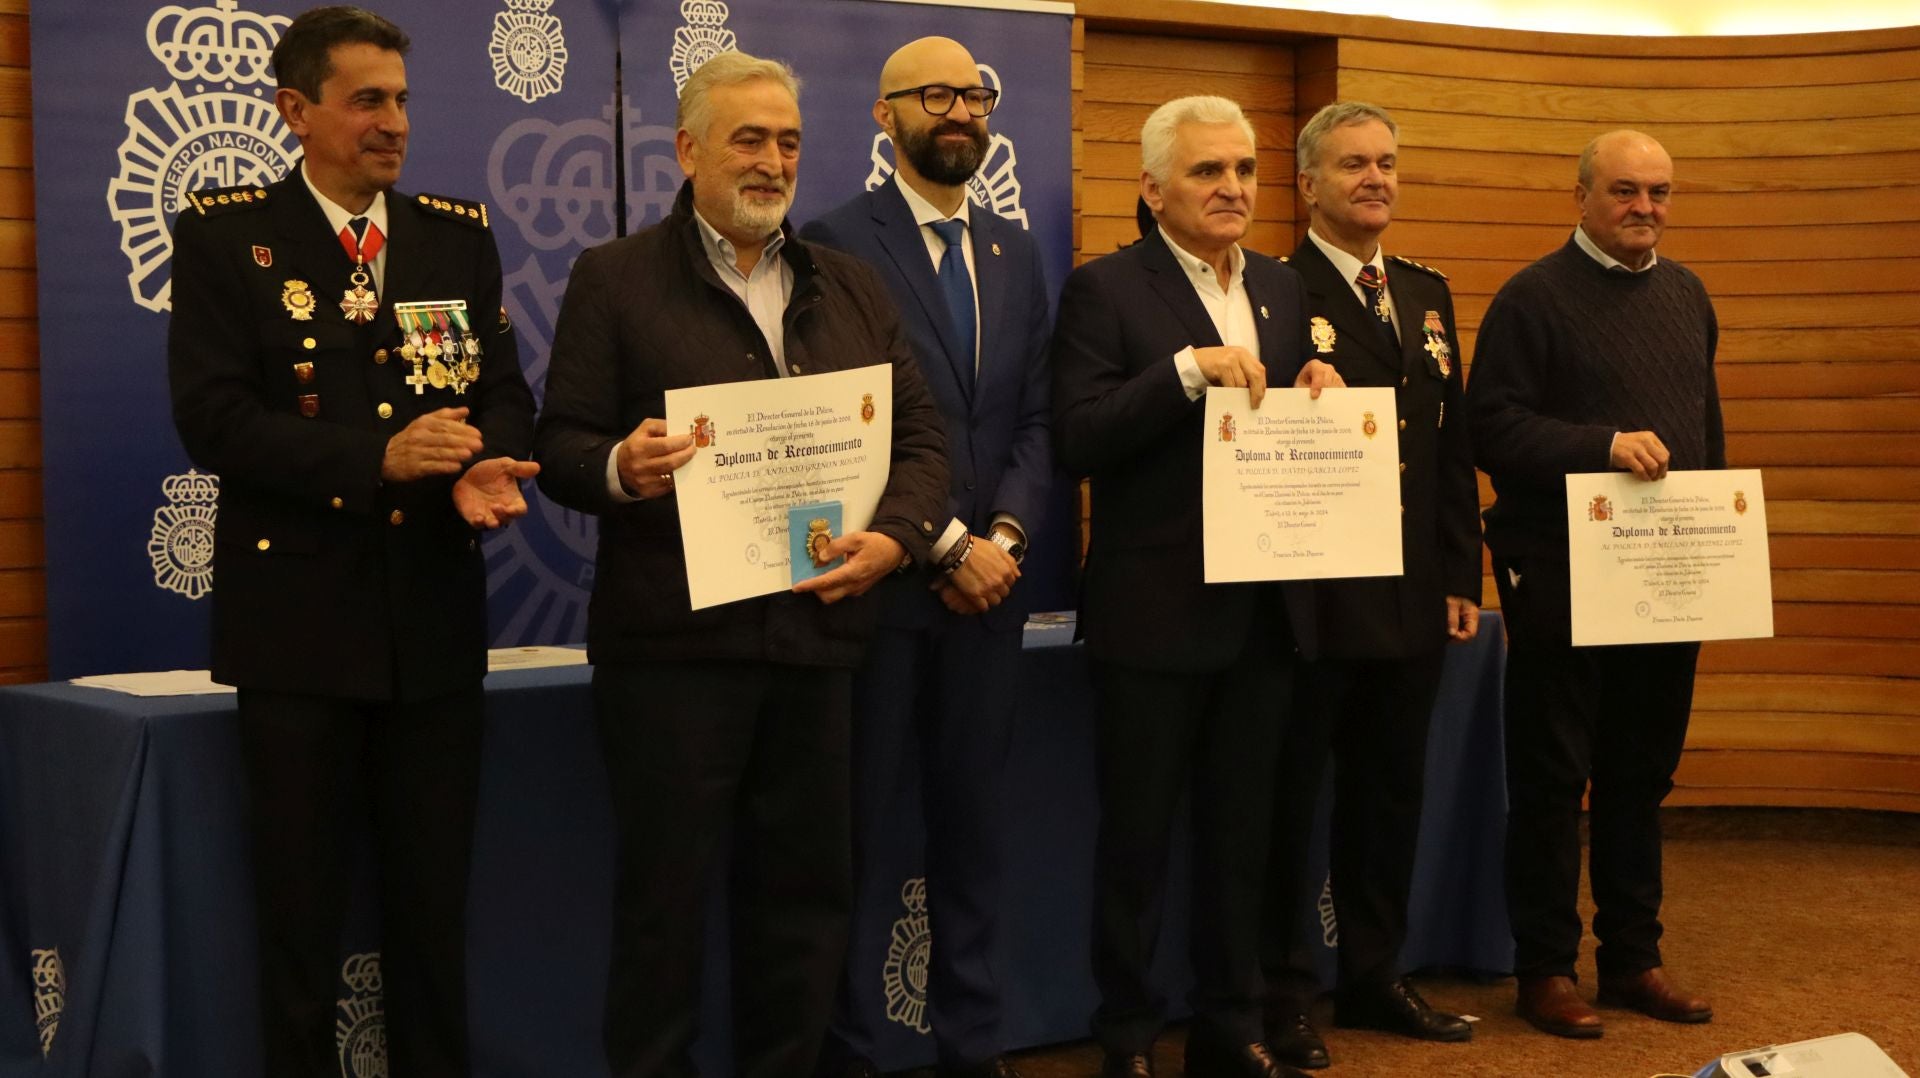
[31,0,616,678]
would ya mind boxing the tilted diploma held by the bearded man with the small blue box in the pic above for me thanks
[666,363,893,609]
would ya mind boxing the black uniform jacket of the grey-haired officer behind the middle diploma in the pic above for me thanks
[1288,238,1480,659]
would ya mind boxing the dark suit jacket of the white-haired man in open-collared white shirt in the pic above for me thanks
[1054,231,1315,671]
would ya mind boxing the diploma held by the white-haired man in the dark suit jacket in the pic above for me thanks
[1200,386,1404,584]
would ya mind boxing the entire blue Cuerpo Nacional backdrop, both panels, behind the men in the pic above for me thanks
[31,0,1077,678]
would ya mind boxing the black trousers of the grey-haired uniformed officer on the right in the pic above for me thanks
[1261,651,1446,1015]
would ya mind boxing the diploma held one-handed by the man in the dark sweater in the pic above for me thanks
[1567,469,1774,646]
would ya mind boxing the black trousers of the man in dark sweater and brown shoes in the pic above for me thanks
[1494,557,1699,976]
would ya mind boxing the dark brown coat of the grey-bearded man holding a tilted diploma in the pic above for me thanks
[534,184,947,667]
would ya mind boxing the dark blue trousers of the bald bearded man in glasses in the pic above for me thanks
[828,617,1020,1066]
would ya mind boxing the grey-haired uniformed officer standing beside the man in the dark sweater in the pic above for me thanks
[1261,102,1480,1068]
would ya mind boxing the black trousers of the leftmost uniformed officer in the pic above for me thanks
[238,686,484,1078]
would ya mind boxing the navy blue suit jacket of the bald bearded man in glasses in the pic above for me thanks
[801,177,1054,626]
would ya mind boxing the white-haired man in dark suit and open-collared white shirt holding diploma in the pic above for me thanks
[1054,98,1340,1078]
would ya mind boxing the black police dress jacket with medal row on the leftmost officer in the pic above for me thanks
[167,169,534,701]
